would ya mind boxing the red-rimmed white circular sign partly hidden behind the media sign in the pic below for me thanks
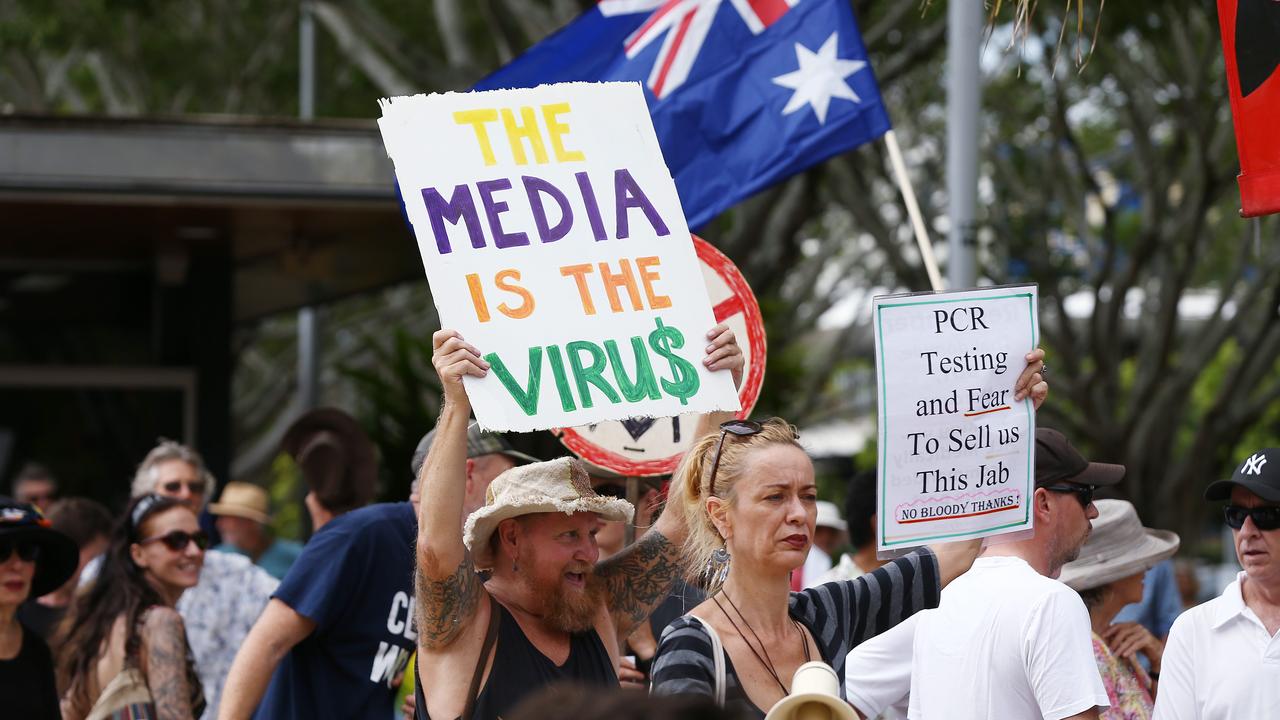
[559,234,765,478]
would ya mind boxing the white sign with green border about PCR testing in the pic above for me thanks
[873,286,1039,551]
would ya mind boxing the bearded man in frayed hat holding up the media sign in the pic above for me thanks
[416,325,744,720]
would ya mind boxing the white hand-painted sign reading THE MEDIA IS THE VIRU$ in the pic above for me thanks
[378,83,739,430]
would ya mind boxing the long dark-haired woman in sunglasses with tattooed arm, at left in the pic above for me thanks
[58,495,209,720]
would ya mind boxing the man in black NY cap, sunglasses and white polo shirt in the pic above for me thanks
[1155,447,1280,720]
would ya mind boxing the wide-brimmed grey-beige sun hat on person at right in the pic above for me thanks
[1059,500,1179,591]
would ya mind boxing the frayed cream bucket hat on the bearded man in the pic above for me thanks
[462,457,635,569]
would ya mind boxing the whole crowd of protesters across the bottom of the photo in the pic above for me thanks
[0,325,1280,720]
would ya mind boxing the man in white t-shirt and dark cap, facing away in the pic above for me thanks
[896,428,1124,720]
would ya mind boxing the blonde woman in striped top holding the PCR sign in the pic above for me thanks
[652,351,1048,717]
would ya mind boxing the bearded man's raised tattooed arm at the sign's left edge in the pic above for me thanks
[416,329,489,650]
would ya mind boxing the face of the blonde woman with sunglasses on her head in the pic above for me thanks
[718,443,818,571]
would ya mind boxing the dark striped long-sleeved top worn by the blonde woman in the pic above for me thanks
[652,548,942,717]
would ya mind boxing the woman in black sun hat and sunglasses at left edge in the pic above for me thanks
[0,497,79,720]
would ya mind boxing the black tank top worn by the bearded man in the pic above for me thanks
[413,602,618,720]
